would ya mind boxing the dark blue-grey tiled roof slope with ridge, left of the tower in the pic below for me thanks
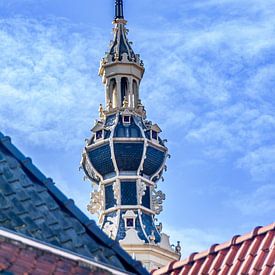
[0,132,147,274]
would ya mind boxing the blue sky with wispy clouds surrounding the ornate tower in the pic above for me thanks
[0,0,275,255]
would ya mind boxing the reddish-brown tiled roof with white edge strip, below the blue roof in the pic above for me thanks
[0,228,114,275]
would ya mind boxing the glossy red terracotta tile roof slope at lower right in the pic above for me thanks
[152,223,275,275]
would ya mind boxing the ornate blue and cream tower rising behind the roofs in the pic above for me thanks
[81,0,180,270]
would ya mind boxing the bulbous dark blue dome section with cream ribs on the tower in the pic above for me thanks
[82,111,167,185]
